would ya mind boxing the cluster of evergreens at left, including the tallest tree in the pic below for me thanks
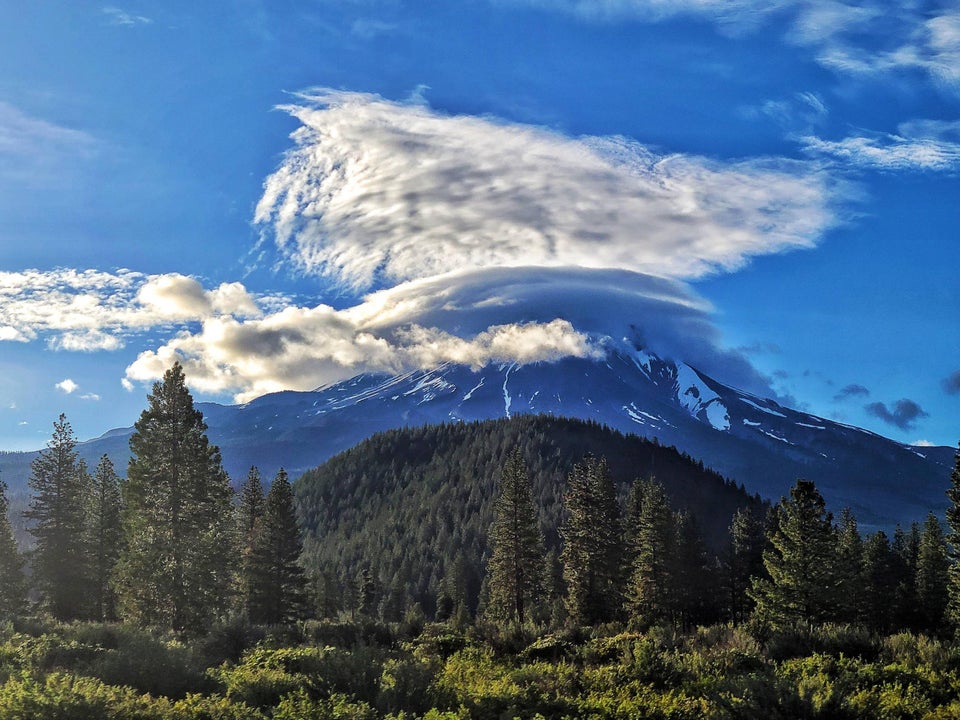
[0,364,307,633]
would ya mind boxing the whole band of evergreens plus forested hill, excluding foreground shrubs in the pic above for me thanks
[0,364,960,644]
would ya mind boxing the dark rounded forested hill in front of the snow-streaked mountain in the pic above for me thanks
[295,416,761,612]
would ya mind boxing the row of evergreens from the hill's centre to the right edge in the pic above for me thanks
[481,454,960,635]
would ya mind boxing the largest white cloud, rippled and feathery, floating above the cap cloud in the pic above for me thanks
[256,91,837,289]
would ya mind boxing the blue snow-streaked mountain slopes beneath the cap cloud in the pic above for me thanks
[0,350,954,527]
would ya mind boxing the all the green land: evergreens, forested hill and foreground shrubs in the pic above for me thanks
[0,365,960,720]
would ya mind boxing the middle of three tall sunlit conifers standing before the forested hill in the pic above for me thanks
[560,457,623,625]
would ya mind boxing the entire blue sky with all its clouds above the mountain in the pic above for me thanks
[0,0,960,449]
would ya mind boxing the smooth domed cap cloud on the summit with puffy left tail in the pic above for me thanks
[127,268,769,402]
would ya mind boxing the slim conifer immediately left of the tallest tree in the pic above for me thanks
[87,455,123,620]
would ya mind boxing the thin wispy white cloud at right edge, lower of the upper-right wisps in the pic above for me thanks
[801,121,960,172]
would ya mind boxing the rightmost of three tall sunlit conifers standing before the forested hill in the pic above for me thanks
[627,480,679,627]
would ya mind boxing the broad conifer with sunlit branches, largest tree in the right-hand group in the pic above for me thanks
[750,480,836,626]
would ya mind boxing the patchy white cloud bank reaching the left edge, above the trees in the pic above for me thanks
[0,268,266,352]
